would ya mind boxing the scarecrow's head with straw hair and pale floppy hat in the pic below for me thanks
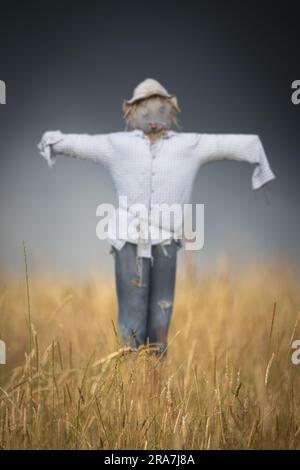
[123,78,180,134]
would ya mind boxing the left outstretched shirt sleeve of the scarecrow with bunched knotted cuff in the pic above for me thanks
[38,131,111,167]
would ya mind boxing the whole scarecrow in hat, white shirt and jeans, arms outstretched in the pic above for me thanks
[38,78,275,356]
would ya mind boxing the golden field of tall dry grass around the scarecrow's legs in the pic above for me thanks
[0,253,300,450]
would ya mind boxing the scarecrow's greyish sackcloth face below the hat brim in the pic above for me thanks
[132,95,172,134]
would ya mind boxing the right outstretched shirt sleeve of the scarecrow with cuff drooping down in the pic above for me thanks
[200,134,275,189]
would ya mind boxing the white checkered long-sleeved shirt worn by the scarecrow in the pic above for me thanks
[38,130,275,258]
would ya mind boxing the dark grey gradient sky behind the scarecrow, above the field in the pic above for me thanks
[0,0,300,277]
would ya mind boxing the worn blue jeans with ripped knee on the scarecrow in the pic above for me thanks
[112,240,179,356]
